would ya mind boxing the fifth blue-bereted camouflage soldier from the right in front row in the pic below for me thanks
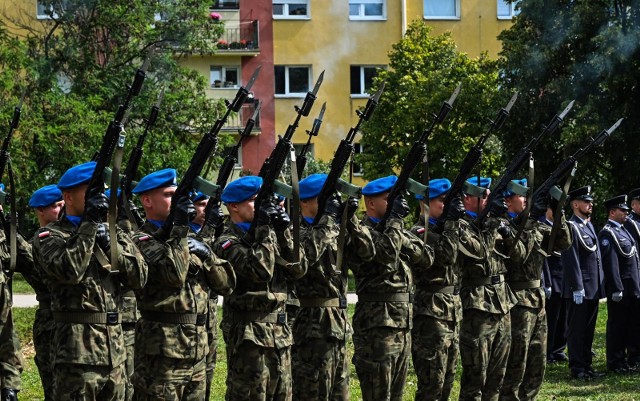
[292,174,375,401]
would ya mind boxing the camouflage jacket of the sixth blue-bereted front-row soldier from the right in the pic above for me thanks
[213,223,307,349]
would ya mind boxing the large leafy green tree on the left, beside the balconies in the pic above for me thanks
[0,0,231,232]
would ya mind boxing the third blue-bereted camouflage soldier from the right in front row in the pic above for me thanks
[411,178,464,400]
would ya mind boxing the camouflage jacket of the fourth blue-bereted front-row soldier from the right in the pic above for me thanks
[350,217,433,332]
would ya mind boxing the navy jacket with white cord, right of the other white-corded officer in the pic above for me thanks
[598,221,640,297]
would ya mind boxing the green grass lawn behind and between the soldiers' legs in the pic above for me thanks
[14,304,640,401]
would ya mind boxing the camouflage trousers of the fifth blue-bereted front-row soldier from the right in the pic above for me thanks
[291,337,349,401]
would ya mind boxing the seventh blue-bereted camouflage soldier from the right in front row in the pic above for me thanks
[133,169,235,401]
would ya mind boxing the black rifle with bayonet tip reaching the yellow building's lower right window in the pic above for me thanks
[313,82,385,225]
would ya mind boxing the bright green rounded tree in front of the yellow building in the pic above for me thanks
[358,21,508,184]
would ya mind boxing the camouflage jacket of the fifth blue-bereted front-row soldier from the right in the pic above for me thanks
[293,214,375,342]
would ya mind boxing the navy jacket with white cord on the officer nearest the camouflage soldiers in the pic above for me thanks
[562,215,604,299]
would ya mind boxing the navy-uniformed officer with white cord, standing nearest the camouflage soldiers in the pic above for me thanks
[561,186,604,380]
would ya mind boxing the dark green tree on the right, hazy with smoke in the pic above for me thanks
[499,0,640,218]
